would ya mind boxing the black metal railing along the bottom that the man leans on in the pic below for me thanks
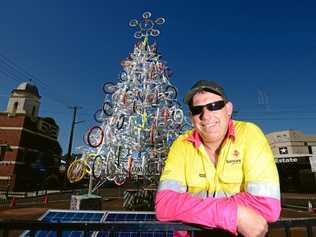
[0,217,316,237]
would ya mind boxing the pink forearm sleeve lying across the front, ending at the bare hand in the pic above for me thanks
[155,190,237,234]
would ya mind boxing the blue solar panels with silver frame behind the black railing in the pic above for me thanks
[21,209,173,237]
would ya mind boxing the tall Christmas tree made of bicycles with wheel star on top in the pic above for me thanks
[67,12,187,192]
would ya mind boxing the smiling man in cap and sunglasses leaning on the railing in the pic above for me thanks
[155,81,281,236]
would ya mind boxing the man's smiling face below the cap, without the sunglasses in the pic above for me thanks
[190,91,233,143]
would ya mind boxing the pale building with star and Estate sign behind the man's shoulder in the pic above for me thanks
[266,130,316,192]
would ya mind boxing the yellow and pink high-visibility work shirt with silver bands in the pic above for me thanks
[156,120,280,232]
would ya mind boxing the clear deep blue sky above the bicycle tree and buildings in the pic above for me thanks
[0,0,316,152]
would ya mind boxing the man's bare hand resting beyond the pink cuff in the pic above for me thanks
[237,205,268,237]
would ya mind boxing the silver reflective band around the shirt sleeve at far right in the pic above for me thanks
[246,182,280,200]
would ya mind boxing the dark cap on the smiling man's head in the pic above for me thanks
[184,80,227,104]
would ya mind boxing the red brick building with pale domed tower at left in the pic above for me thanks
[0,82,62,191]
